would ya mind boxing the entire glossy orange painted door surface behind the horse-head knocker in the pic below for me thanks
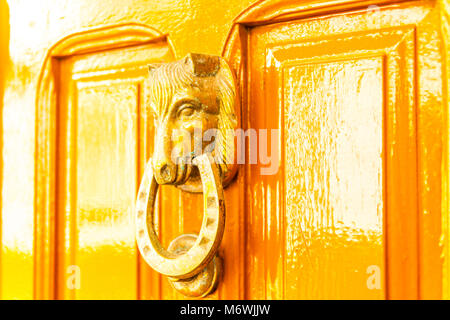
[0,0,450,299]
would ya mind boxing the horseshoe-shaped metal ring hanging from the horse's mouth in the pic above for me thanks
[136,153,225,279]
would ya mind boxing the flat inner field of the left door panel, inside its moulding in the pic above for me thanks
[73,83,139,299]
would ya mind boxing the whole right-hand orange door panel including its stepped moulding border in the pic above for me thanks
[244,3,442,299]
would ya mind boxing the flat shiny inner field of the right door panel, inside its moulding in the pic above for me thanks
[282,58,384,299]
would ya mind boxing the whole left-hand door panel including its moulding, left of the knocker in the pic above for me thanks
[56,44,172,299]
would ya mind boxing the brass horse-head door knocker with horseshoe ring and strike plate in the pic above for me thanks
[136,54,237,297]
